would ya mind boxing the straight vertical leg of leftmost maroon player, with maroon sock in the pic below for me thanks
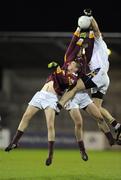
[45,107,55,166]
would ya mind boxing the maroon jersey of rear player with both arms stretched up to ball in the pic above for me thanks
[65,31,94,77]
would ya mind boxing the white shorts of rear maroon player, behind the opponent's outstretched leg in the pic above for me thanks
[65,91,93,110]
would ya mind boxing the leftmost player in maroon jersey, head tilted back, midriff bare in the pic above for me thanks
[5,29,86,165]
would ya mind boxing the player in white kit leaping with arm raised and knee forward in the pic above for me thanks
[58,14,121,144]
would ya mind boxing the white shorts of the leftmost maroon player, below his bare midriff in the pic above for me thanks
[28,90,58,110]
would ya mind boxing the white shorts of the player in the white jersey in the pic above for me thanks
[91,69,110,94]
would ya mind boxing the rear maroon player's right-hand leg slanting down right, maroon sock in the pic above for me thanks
[86,103,115,145]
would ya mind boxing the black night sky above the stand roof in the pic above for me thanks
[0,0,121,32]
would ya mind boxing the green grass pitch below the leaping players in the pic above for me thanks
[0,149,121,180]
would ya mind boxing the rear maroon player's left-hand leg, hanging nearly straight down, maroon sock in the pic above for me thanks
[69,108,88,161]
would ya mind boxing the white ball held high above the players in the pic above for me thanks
[78,16,91,29]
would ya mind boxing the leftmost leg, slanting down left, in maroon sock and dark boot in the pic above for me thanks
[5,105,39,151]
